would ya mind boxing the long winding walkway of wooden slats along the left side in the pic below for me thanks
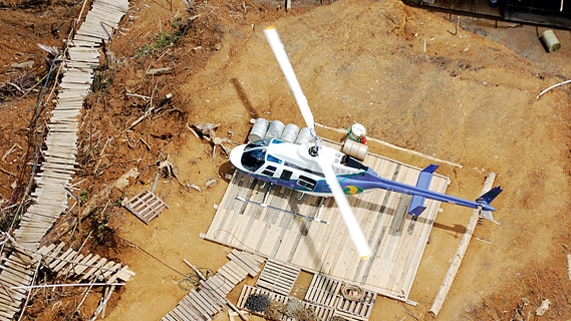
[0,0,129,320]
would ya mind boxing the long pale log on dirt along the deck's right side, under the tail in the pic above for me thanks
[428,172,496,317]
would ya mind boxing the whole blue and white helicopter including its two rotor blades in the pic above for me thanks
[230,26,502,258]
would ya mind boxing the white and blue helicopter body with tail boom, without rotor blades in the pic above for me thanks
[230,138,495,211]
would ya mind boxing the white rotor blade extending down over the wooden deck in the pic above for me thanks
[317,156,371,259]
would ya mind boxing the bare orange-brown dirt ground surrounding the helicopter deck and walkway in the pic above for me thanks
[0,0,571,321]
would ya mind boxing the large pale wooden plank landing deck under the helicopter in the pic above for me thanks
[205,142,449,301]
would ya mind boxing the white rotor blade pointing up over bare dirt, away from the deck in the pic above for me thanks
[264,26,315,131]
